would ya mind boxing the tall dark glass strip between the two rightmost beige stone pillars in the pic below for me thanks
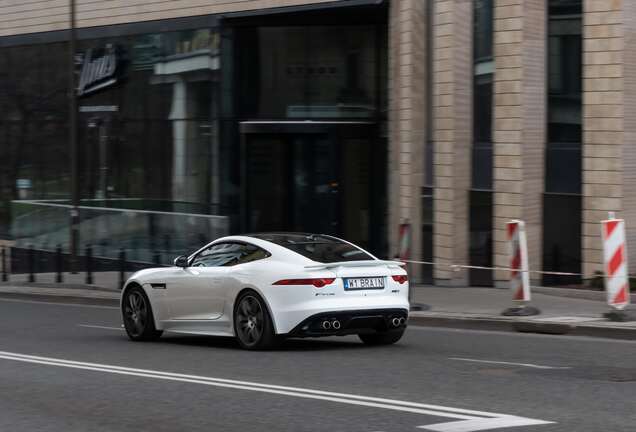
[543,0,582,285]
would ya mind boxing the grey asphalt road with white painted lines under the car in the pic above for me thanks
[0,299,636,432]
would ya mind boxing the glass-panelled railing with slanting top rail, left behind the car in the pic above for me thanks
[11,200,229,263]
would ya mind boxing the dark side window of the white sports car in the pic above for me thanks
[190,243,270,267]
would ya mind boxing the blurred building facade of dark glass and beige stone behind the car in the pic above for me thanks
[0,0,636,286]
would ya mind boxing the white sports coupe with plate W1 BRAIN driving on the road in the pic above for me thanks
[121,233,409,349]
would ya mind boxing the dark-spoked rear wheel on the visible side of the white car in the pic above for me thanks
[233,290,282,350]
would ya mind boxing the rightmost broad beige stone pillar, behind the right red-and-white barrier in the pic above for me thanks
[582,0,624,278]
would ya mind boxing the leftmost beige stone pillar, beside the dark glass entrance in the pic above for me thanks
[388,0,428,270]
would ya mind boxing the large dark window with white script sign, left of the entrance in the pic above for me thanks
[0,28,229,262]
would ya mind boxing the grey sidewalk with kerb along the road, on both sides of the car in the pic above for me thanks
[0,280,636,340]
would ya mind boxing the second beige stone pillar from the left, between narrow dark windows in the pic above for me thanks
[432,0,473,285]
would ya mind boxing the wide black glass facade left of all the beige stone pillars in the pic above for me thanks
[0,5,388,259]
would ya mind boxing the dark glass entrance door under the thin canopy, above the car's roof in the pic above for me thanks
[245,134,340,235]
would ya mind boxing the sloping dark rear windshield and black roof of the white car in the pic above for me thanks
[253,234,374,263]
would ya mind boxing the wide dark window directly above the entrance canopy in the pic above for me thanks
[236,25,379,119]
